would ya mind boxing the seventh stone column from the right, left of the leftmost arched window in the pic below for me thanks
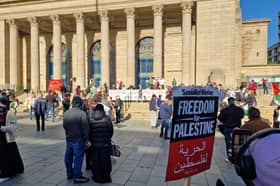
[28,17,40,92]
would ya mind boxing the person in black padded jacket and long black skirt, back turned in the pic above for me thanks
[89,104,113,183]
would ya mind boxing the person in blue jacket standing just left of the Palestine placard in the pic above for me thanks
[159,98,172,139]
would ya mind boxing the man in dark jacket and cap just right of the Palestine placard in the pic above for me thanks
[218,97,244,161]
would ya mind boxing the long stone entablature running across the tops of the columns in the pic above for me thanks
[0,0,203,19]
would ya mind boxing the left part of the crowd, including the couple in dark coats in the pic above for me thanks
[0,83,123,183]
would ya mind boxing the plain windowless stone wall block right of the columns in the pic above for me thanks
[196,0,236,87]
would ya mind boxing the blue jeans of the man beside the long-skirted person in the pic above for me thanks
[64,139,85,178]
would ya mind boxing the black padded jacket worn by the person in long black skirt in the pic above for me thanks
[89,109,113,148]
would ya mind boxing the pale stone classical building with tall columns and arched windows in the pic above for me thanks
[0,0,280,90]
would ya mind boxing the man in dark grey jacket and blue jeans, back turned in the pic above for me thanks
[63,96,89,183]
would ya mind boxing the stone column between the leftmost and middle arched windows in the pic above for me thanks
[73,13,86,89]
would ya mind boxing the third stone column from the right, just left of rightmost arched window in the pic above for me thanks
[125,8,137,87]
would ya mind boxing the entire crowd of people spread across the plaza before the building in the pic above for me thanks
[0,78,280,183]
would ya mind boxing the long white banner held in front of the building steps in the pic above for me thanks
[109,89,166,101]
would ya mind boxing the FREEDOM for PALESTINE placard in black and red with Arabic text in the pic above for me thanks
[165,87,218,181]
